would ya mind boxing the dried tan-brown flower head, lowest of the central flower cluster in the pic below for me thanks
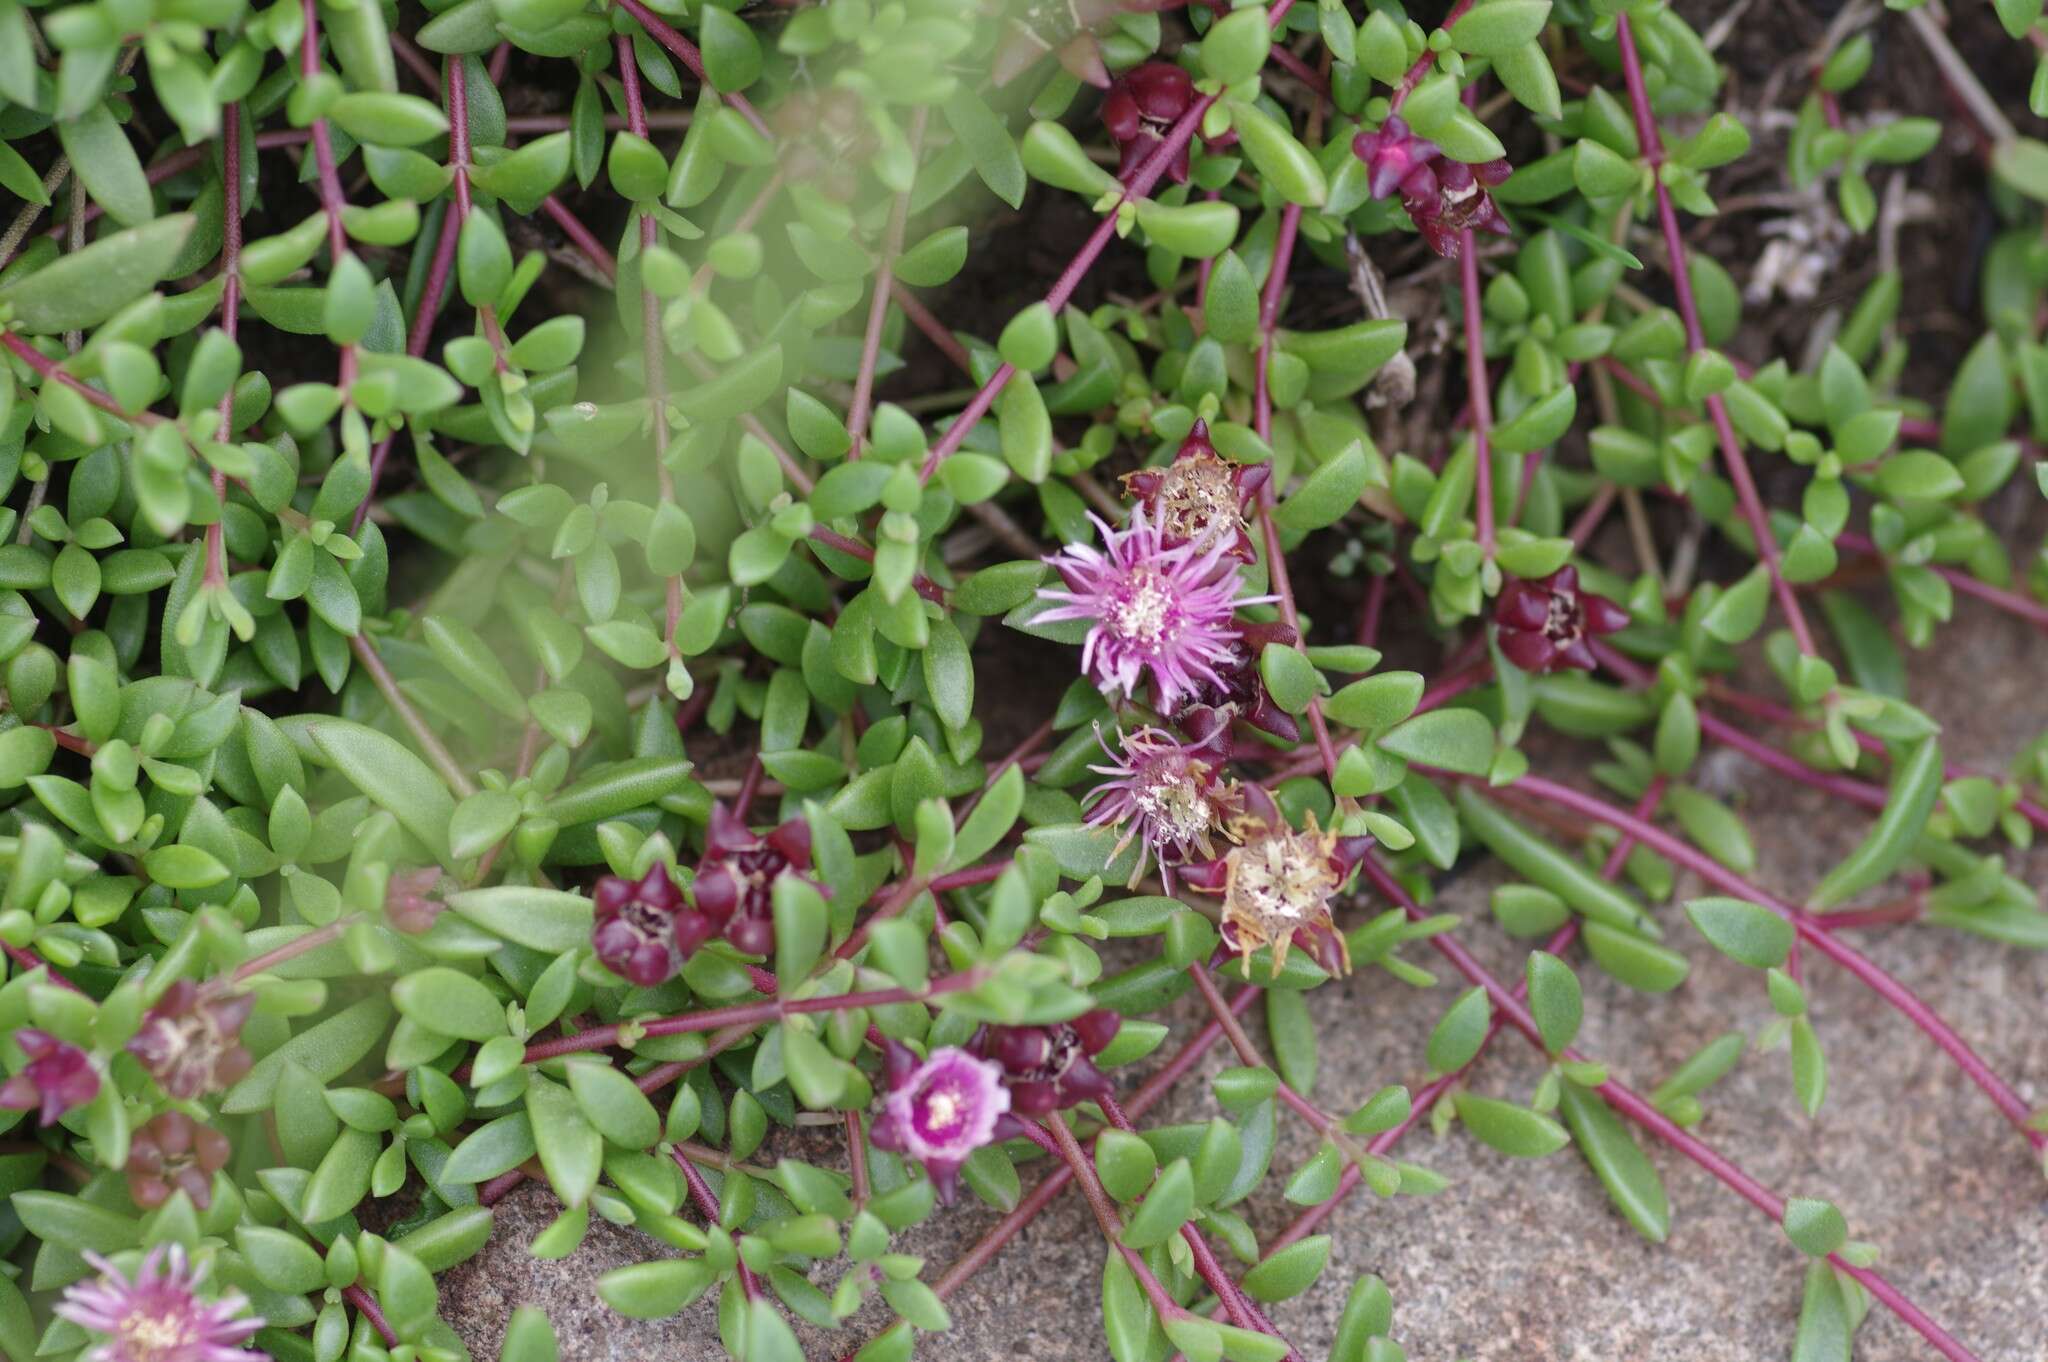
[1182,784,1372,973]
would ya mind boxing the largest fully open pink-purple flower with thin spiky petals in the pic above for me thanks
[1038,506,1276,713]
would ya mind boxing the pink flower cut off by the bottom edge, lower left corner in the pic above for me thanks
[57,1245,262,1362]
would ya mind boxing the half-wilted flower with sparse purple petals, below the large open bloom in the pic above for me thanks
[1087,727,1239,893]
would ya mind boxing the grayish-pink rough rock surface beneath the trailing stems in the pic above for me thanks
[442,604,2048,1362]
